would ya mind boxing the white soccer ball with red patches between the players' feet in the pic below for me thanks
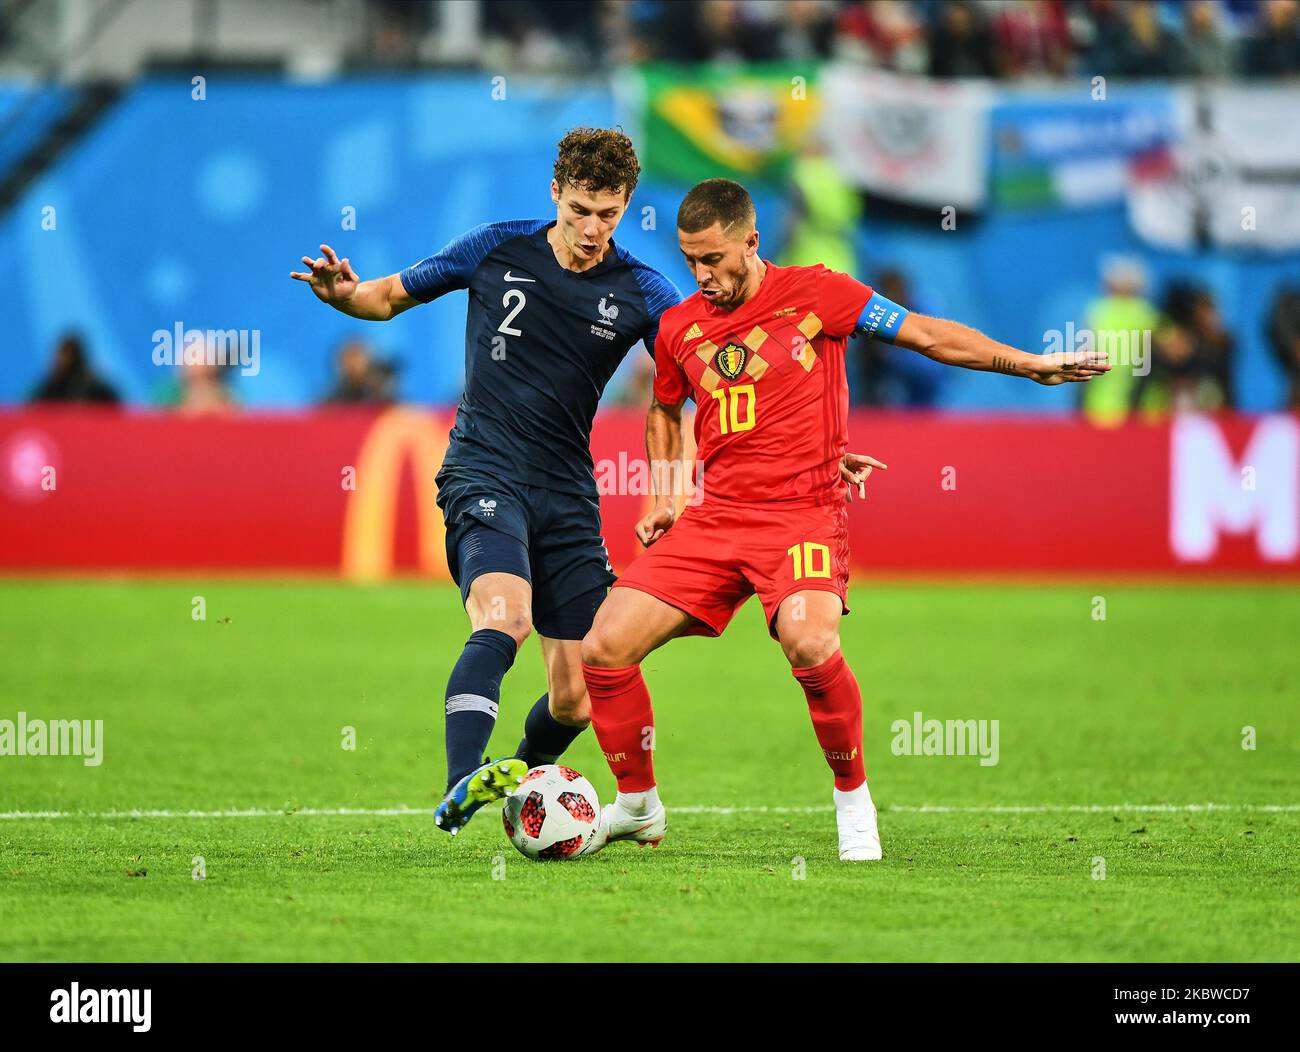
[501,763,601,861]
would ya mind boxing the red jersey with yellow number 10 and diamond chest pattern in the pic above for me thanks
[654,260,871,503]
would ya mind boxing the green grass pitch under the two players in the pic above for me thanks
[0,580,1300,961]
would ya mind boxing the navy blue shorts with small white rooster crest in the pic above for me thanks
[438,472,614,640]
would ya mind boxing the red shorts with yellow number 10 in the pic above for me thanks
[614,501,849,638]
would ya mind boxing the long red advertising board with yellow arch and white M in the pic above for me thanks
[0,407,1300,580]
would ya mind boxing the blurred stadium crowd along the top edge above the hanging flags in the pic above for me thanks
[457,0,1300,79]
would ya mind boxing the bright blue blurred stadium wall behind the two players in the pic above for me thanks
[0,74,1300,412]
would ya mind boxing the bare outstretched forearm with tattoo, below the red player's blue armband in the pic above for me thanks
[893,313,1110,385]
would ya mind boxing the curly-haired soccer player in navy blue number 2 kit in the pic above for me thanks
[290,127,681,834]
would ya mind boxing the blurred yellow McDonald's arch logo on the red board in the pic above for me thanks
[342,407,450,581]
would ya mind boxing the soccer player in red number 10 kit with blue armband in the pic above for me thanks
[581,179,1110,861]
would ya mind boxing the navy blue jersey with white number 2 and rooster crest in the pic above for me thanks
[400,220,681,497]
